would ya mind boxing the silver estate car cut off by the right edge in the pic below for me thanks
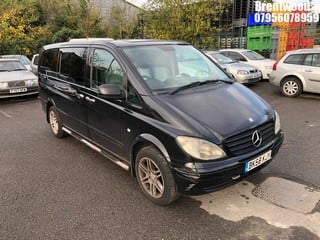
[269,49,320,97]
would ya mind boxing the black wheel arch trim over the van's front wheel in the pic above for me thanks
[130,133,171,176]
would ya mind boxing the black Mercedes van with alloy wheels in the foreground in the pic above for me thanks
[38,39,283,205]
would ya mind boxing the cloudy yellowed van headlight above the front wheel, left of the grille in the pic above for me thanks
[176,136,226,160]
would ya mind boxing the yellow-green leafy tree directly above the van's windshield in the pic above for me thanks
[143,0,225,49]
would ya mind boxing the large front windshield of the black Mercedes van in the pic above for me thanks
[124,44,231,91]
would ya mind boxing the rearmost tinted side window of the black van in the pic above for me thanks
[39,49,59,73]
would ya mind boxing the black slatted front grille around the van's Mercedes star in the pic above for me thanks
[224,122,274,156]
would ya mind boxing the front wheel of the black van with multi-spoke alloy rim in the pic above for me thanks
[135,146,180,205]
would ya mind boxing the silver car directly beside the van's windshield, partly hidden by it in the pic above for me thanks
[205,51,262,84]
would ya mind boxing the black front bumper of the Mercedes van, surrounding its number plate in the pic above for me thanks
[174,131,284,195]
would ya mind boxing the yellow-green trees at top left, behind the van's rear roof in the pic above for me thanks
[0,0,106,56]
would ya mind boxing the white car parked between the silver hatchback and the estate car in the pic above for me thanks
[220,49,275,79]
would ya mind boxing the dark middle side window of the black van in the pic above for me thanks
[60,48,88,85]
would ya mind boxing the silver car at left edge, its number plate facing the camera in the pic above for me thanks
[0,58,39,98]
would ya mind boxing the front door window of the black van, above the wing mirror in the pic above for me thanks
[91,49,123,88]
